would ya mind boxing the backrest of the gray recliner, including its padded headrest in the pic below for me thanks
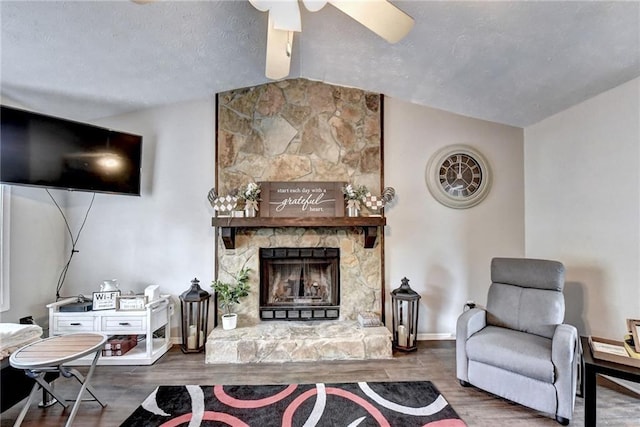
[487,258,564,338]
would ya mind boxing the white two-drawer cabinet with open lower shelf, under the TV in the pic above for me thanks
[47,296,173,365]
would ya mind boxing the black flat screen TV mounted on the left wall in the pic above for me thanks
[0,105,142,196]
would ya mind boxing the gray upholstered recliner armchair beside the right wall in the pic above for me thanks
[456,258,580,425]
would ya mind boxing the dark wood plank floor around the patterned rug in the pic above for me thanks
[1,341,640,427]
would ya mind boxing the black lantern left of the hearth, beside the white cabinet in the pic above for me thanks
[180,279,211,353]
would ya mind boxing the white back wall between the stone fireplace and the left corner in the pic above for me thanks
[67,97,215,336]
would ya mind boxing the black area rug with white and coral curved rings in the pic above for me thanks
[122,381,466,427]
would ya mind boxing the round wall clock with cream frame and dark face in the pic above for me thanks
[425,145,491,209]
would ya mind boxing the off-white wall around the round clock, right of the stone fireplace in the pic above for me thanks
[384,98,524,339]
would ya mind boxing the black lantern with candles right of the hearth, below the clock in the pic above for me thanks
[391,277,420,351]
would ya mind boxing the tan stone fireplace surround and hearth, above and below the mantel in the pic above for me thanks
[206,79,392,363]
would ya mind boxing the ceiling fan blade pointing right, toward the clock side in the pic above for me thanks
[329,0,414,43]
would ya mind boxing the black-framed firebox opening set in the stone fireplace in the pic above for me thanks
[260,248,340,320]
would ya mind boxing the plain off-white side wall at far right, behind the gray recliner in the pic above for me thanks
[525,79,640,340]
